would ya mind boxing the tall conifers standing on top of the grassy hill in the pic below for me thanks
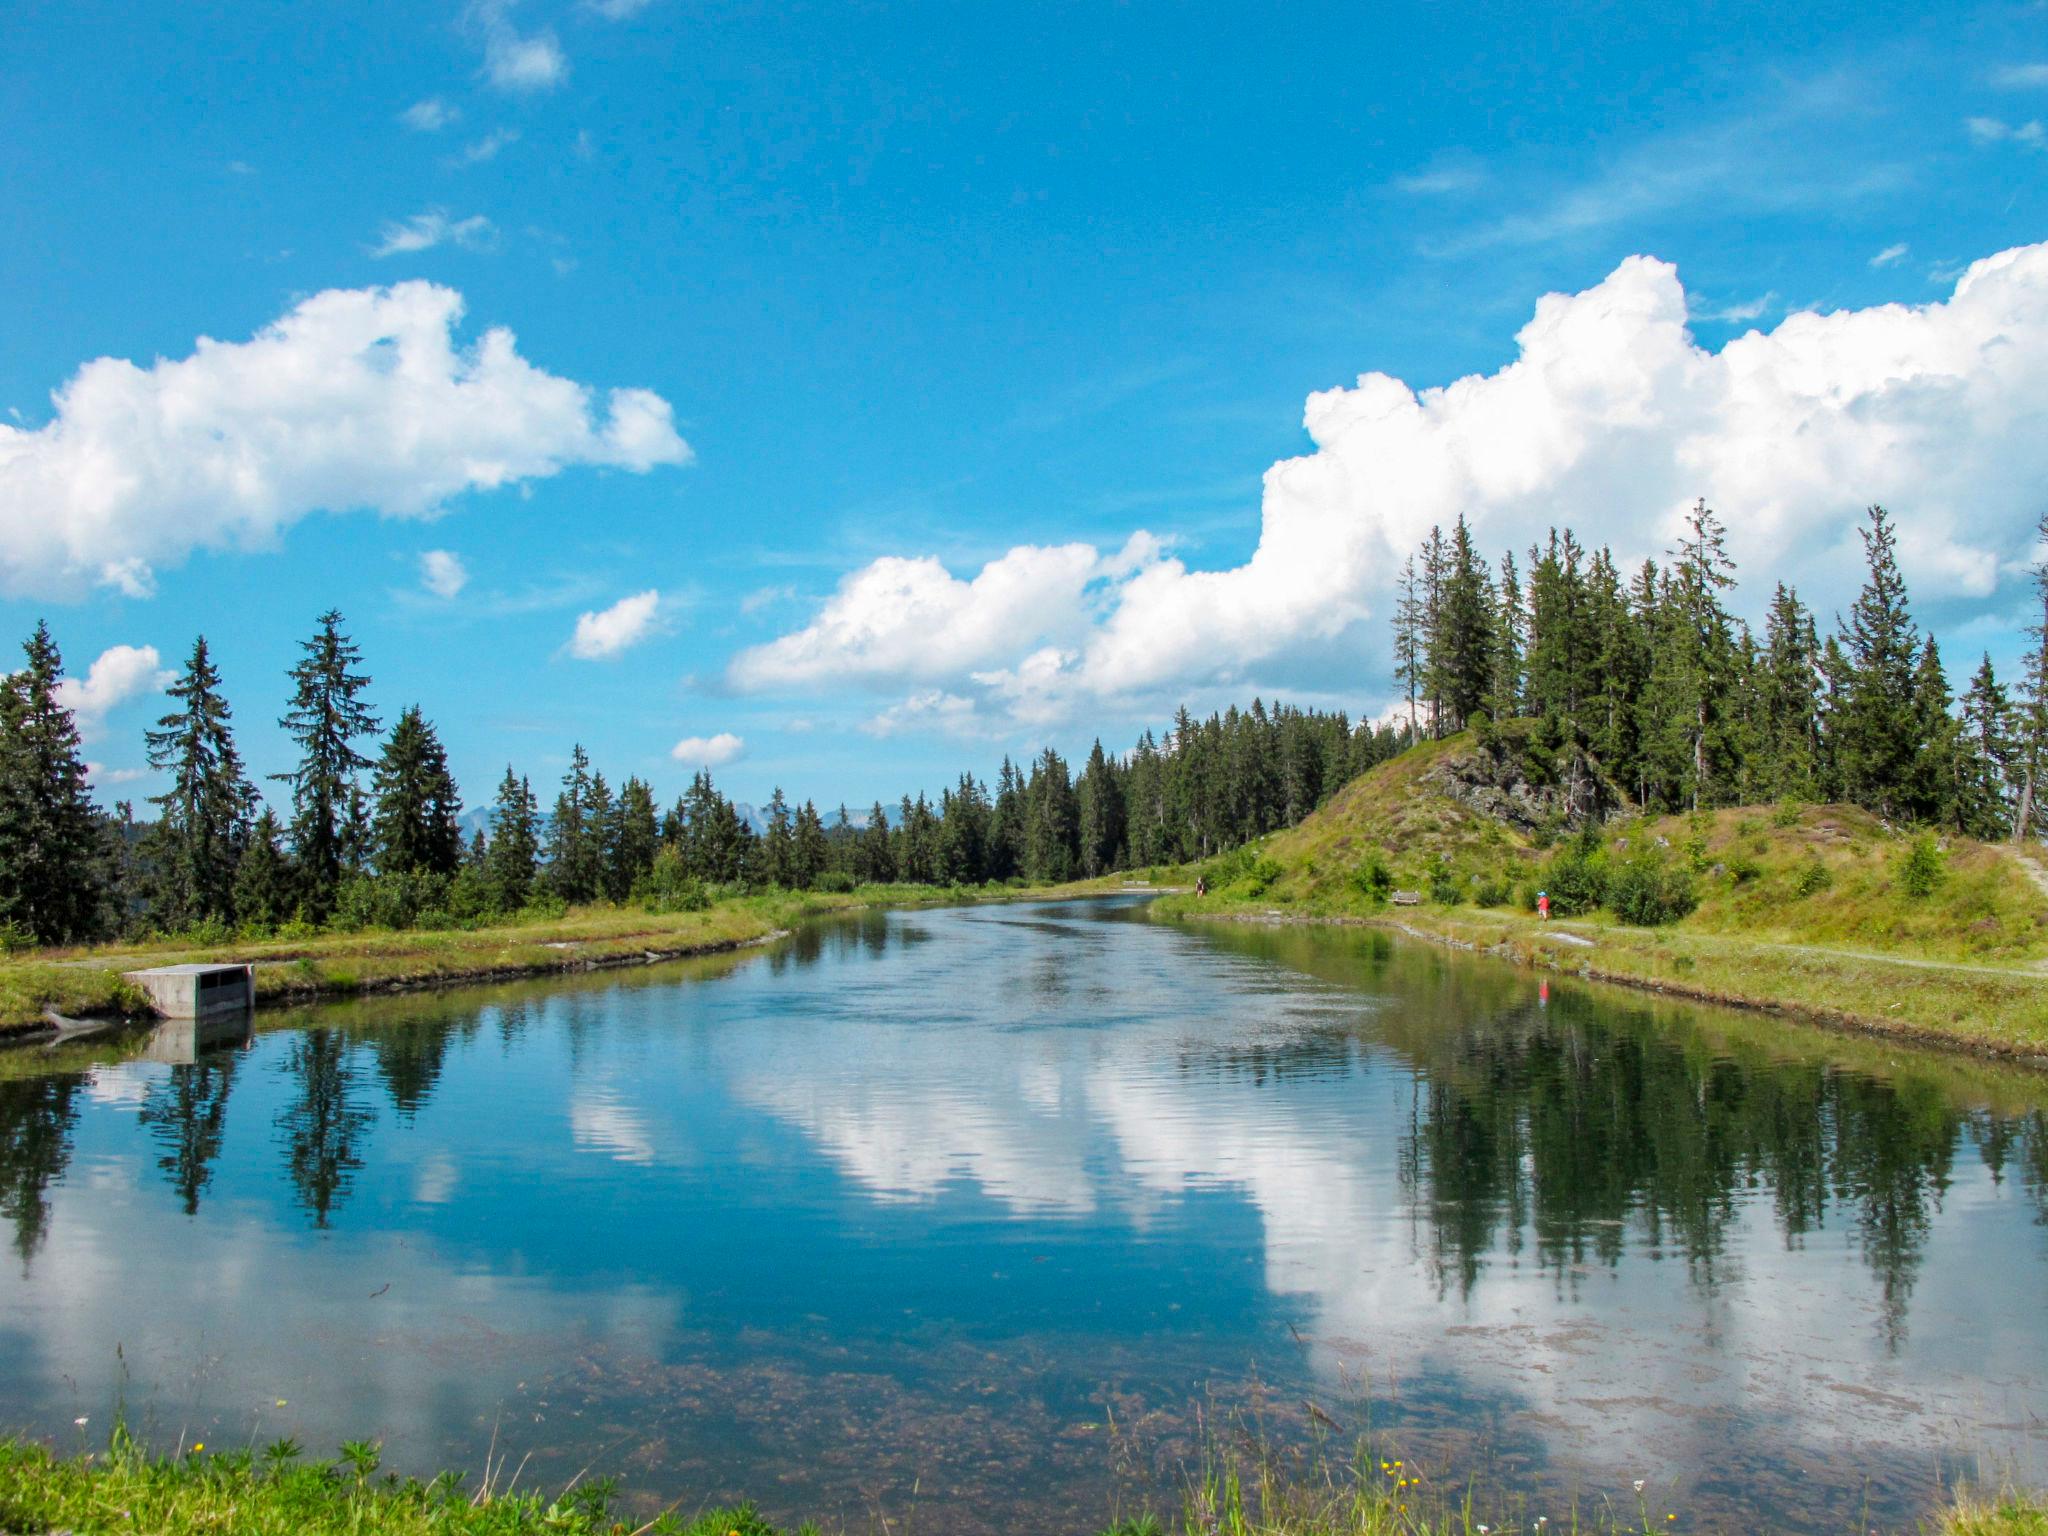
[1393,502,2048,838]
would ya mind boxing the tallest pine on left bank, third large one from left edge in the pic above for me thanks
[276,608,377,918]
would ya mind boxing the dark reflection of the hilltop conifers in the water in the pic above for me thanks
[1399,1006,2007,1343]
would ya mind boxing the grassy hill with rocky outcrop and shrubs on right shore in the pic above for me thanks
[1163,733,2048,1055]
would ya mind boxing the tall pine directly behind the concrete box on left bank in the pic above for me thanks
[143,635,258,928]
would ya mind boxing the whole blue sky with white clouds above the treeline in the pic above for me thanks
[0,0,2048,819]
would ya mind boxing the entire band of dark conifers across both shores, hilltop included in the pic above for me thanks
[0,502,2048,946]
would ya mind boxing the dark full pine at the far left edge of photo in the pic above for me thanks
[0,623,104,944]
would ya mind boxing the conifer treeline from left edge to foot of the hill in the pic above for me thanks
[0,612,1405,946]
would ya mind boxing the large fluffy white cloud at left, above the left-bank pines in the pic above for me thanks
[0,283,690,596]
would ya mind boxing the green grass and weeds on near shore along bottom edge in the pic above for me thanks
[0,1430,2048,1536]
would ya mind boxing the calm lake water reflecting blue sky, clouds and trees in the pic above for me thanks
[0,903,2048,1532]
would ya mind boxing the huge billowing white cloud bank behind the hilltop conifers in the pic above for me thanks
[731,246,2048,721]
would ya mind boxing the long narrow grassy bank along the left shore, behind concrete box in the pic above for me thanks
[0,877,1155,1036]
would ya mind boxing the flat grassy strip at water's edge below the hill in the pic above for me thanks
[1161,905,2048,1071]
